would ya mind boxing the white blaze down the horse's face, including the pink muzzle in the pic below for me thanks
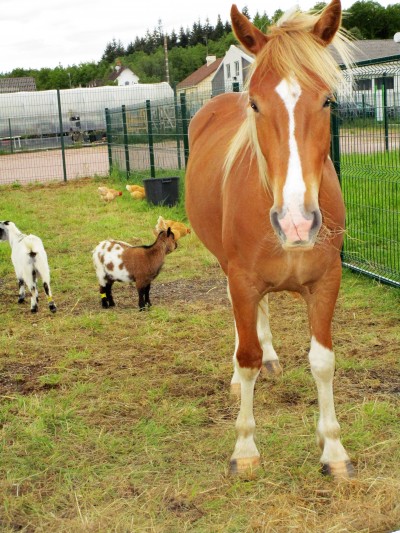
[271,78,321,249]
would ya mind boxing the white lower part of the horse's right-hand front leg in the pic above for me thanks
[309,337,350,474]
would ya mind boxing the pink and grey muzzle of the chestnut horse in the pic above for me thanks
[270,208,322,250]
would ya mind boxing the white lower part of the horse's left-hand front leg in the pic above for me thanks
[231,364,260,473]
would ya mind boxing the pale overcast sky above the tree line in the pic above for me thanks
[0,0,396,74]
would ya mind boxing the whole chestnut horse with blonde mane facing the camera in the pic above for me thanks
[186,0,353,477]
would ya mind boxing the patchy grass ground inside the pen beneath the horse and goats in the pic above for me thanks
[0,180,400,533]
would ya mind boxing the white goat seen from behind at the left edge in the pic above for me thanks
[0,220,57,313]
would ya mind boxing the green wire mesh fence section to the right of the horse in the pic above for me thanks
[332,56,400,286]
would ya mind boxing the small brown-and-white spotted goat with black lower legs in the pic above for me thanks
[93,228,177,311]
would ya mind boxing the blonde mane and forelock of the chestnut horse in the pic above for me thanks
[224,8,355,185]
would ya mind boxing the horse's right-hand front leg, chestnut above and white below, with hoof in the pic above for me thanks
[306,265,354,478]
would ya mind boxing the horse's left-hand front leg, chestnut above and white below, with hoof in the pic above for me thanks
[229,277,263,473]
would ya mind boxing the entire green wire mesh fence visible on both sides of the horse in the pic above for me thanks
[0,70,400,287]
